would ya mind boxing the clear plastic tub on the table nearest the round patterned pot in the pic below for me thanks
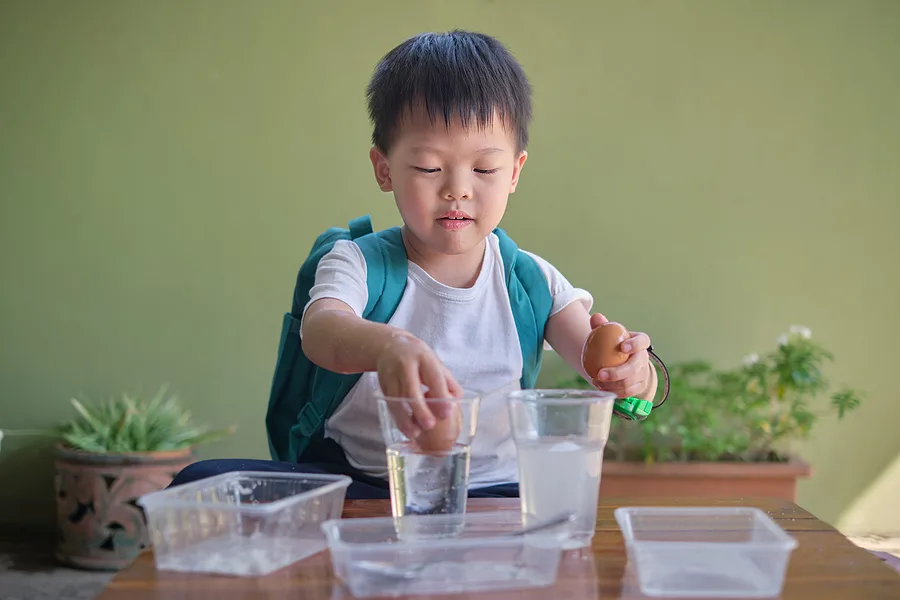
[138,471,351,576]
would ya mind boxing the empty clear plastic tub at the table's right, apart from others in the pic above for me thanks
[615,507,797,598]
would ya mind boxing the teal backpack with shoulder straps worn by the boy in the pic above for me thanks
[266,215,553,462]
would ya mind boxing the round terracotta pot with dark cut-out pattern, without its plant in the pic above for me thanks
[55,445,193,570]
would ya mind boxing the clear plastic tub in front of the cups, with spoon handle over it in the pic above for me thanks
[322,511,565,597]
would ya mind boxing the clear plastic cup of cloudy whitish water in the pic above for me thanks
[507,390,616,549]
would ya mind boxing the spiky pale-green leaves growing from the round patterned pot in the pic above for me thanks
[0,386,235,454]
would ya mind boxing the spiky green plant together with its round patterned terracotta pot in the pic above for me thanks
[6,386,234,570]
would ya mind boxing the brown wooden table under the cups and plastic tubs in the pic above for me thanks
[98,498,900,600]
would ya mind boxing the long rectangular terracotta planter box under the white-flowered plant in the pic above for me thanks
[600,458,812,502]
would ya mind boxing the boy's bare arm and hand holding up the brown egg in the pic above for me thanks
[545,302,657,401]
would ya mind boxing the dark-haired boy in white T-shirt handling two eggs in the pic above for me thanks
[172,31,656,498]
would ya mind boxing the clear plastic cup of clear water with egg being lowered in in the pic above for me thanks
[377,393,480,537]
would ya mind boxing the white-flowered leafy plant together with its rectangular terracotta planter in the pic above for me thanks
[558,326,861,501]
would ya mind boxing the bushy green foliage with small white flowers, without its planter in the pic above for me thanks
[558,326,862,462]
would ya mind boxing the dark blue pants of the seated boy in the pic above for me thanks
[169,439,519,500]
